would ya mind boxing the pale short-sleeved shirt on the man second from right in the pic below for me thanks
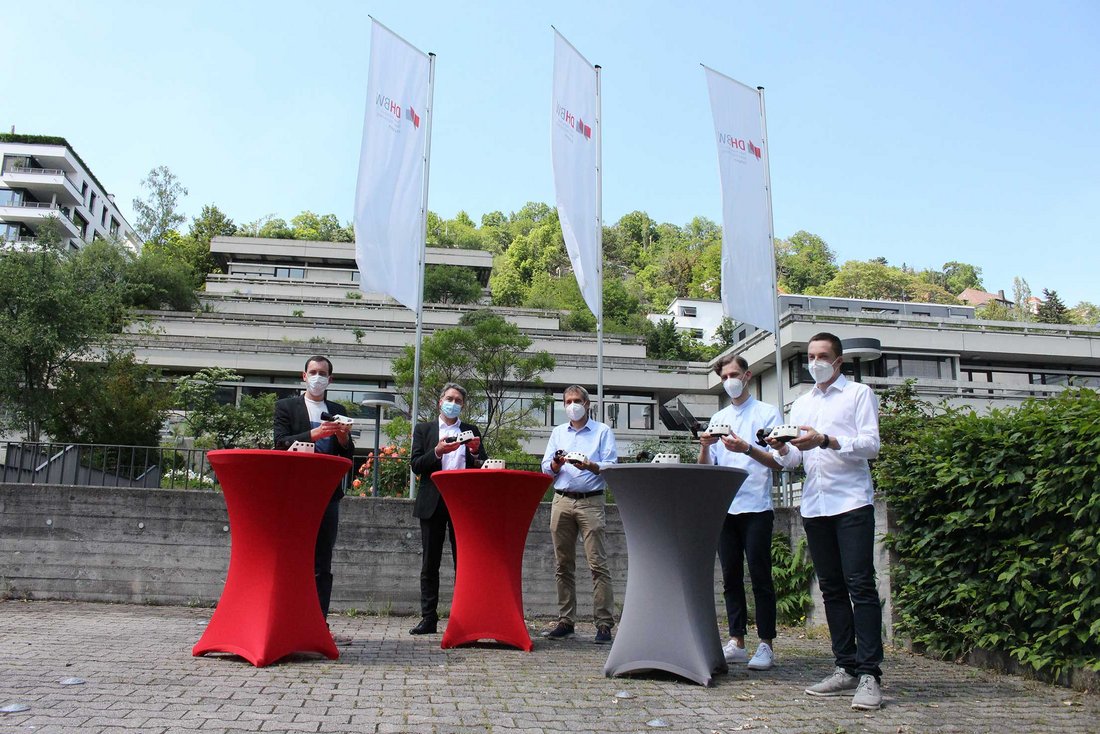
[708,395,783,515]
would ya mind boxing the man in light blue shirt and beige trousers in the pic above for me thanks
[542,385,618,645]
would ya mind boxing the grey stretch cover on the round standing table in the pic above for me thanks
[602,464,748,686]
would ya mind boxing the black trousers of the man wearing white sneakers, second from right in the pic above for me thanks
[718,510,776,639]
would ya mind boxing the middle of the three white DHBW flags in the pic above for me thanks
[550,31,603,319]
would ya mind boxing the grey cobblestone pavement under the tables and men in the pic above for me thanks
[0,601,1100,734]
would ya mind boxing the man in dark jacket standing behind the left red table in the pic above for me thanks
[274,355,355,617]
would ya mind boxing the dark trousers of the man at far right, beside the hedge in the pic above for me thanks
[802,505,882,679]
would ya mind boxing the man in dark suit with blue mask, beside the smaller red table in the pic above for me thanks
[409,382,486,635]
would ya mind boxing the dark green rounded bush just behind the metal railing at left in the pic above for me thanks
[44,350,169,446]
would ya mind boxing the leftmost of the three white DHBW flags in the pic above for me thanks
[355,21,430,310]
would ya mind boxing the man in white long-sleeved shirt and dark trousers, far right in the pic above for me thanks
[768,332,882,710]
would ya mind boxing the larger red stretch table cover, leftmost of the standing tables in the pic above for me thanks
[191,449,351,667]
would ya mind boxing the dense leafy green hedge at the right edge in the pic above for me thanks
[875,387,1100,675]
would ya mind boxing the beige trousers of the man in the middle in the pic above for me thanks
[550,493,615,627]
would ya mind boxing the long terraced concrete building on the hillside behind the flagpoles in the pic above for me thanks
[124,237,1100,453]
